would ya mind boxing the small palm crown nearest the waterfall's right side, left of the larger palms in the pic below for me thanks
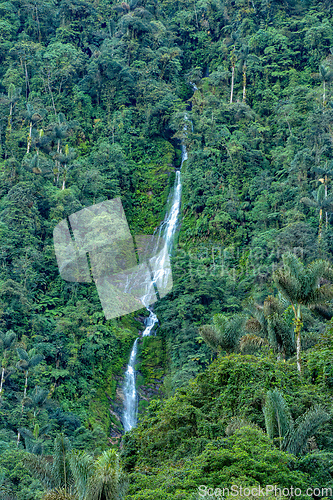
[199,314,244,353]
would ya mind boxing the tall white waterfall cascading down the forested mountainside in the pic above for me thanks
[123,124,188,432]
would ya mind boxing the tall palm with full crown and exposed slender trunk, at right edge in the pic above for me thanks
[273,253,333,372]
